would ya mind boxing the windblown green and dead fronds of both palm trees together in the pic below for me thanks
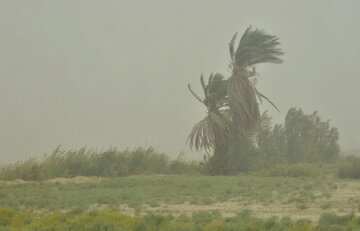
[188,27,283,151]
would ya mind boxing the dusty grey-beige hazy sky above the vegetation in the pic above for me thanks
[0,0,360,163]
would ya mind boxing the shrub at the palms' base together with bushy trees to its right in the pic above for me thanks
[198,108,340,175]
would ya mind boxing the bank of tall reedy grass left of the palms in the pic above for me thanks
[0,147,201,181]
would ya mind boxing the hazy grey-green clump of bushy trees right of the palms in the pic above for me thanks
[254,108,340,166]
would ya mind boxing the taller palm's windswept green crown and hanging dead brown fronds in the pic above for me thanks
[228,27,283,134]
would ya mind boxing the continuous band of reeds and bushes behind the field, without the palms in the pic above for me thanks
[0,105,352,180]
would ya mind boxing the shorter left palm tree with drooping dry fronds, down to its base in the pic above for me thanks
[187,74,233,174]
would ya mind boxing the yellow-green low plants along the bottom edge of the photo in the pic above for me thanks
[0,209,360,231]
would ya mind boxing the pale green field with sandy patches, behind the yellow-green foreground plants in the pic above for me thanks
[0,174,360,230]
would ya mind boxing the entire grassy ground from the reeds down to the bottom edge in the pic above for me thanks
[0,174,360,231]
